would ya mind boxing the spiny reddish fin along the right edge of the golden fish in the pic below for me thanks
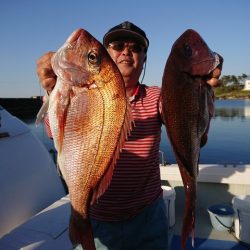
[91,101,134,205]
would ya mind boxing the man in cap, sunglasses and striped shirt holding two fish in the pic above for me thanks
[37,22,220,250]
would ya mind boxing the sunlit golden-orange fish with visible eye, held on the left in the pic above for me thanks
[37,29,132,250]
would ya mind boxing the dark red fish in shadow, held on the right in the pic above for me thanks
[162,29,223,249]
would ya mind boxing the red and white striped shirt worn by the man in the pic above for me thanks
[45,85,162,221]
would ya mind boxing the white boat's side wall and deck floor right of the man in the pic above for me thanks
[161,165,250,250]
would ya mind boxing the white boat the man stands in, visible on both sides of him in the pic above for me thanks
[0,108,250,250]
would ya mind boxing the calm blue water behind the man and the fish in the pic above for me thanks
[24,100,250,164]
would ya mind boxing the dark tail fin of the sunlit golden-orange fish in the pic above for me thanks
[69,212,96,250]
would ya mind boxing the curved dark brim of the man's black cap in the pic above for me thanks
[103,29,148,48]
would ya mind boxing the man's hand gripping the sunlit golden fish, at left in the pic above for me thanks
[36,51,56,92]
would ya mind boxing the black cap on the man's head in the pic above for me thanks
[103,21,149,50]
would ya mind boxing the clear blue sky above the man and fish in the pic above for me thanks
[0,0,250,98]
